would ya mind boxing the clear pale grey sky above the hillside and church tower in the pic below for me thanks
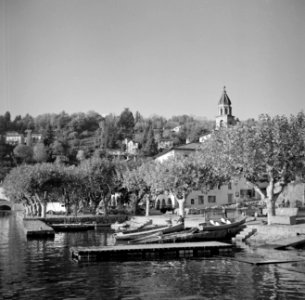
[0,0,305,120]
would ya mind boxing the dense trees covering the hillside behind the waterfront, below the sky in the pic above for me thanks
[0,108,214,180]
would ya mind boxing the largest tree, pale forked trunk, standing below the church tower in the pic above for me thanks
[203,112,305,224]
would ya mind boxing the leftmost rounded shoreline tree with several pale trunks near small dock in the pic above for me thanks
[3,163,85,217]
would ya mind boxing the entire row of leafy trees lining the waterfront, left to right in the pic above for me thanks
[4,112,305,224]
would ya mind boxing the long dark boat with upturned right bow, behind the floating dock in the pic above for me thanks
[133,218,246,244]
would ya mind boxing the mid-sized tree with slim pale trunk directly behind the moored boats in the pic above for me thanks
[124,154,223,216]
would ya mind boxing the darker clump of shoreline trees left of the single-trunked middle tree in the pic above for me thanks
[3,157,132,217]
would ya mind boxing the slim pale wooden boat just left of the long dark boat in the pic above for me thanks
[113,223,184,241]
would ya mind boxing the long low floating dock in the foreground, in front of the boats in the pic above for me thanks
[70,241,233,262]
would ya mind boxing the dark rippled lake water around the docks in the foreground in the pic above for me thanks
[0,214,305,300]
